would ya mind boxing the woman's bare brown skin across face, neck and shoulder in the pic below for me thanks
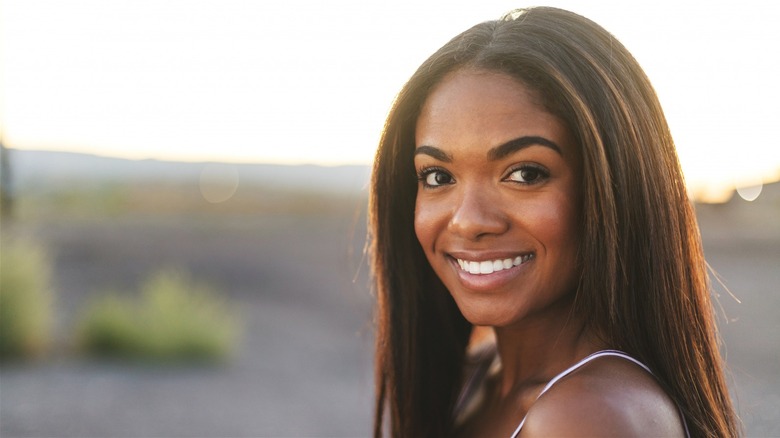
[414,68,684,437]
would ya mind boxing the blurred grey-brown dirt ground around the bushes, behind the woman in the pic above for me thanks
[0,197,780,437]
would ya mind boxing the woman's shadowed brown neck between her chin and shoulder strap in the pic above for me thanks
[495,304,605,398]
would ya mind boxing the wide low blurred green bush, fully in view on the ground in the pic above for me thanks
[77,270,239,362]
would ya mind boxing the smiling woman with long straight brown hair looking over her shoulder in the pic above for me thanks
[370,8,739,437]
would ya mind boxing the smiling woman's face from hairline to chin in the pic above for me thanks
[414,69,580,326]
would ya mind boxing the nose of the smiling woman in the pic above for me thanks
[449,187,509,240]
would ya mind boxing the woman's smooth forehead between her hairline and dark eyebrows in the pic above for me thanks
[415,69,568,154]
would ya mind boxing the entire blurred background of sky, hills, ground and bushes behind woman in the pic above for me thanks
[0,0,780,437]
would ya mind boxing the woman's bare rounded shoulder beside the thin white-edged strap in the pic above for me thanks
[520,357,685,437]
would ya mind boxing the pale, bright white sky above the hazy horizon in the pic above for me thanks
[0,0,780,202]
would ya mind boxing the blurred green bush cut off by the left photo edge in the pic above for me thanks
[0,239,54,359]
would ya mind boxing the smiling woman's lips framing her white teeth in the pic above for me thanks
[447,251,536,292]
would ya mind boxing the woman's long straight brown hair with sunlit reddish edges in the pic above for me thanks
[370,8,740,436]
